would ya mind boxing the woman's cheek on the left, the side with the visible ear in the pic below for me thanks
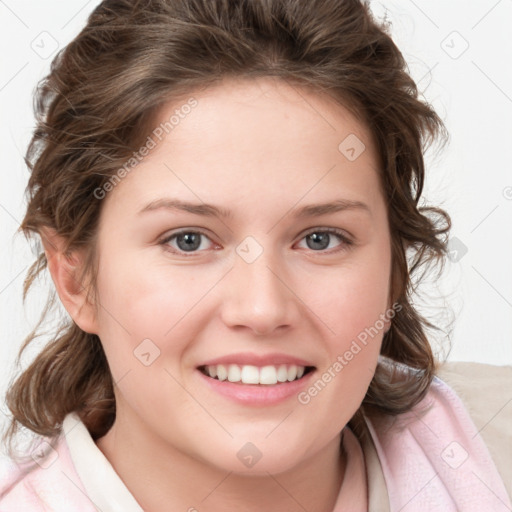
[93,258,219,368]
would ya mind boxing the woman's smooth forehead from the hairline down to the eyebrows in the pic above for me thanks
[102,78,379,218]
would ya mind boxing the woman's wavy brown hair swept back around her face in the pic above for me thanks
[2,0,450,448]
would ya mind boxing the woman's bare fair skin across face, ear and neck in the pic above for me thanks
[45,78,391,512]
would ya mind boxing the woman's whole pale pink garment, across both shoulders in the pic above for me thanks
[0,378,512,512]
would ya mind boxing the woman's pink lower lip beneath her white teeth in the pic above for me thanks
[197,370,315,406]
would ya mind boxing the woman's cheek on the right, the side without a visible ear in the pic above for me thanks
[301,250,393,414]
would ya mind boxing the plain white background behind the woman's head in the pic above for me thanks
[0,0,512,434]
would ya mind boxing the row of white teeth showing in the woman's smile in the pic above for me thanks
[204,364,305,386]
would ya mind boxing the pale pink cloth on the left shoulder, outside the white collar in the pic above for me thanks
[0,436,96,512]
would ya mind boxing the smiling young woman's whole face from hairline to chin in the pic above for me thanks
[90,79,393,474]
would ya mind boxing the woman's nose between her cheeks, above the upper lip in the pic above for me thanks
[221,244,300,336]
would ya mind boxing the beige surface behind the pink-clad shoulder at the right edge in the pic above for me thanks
[432,362,512,496]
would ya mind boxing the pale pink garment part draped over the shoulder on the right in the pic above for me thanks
[367,377,512,512]
